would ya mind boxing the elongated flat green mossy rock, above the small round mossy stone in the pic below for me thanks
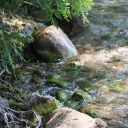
[46,79,69,88]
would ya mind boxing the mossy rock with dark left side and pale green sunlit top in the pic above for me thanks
[72,90,92,102]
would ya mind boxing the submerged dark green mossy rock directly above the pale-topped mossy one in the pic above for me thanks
[76,80,91,91]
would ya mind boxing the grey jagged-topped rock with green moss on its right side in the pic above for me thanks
[23,93,59,115]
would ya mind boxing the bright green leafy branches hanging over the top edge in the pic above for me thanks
[0,0,93,26]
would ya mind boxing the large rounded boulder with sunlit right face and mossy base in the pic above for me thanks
[33,25,77,61]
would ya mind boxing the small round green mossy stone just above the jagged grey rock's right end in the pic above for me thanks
[56,91,68,102]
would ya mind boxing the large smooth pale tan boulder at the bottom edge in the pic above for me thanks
[44,108,108,128]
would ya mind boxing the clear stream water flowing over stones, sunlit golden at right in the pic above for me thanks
[14,0,128,128]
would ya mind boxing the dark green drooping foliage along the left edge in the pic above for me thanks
[0,21,29,77]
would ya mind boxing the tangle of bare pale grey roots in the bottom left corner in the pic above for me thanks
[0,104,43,128]
